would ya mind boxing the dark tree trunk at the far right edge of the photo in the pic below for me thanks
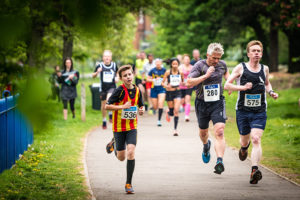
[285,28,300,73]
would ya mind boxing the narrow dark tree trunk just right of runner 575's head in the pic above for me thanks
[269,20,278,72]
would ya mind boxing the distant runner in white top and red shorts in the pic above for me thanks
[142,54,155,114]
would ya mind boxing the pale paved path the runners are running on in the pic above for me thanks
[86,108,300,200]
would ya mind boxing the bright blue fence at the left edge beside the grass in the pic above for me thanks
[0,95,33,173]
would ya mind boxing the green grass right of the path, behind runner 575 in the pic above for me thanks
[225,88,300,183]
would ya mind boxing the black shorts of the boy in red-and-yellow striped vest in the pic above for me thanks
[114,129,137,151]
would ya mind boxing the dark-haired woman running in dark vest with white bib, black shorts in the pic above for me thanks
[163,58,183,136]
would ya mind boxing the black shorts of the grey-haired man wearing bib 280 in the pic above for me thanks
[195,98,227,129]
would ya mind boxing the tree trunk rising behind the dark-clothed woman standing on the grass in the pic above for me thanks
[62,16,74,66]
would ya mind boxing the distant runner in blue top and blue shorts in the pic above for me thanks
[147,59,166,126]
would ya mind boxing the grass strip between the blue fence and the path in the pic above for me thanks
[0,77,101,200]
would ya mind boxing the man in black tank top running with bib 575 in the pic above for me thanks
[224,40,278,184]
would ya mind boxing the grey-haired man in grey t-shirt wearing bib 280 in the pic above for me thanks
[187,43,229,174]
